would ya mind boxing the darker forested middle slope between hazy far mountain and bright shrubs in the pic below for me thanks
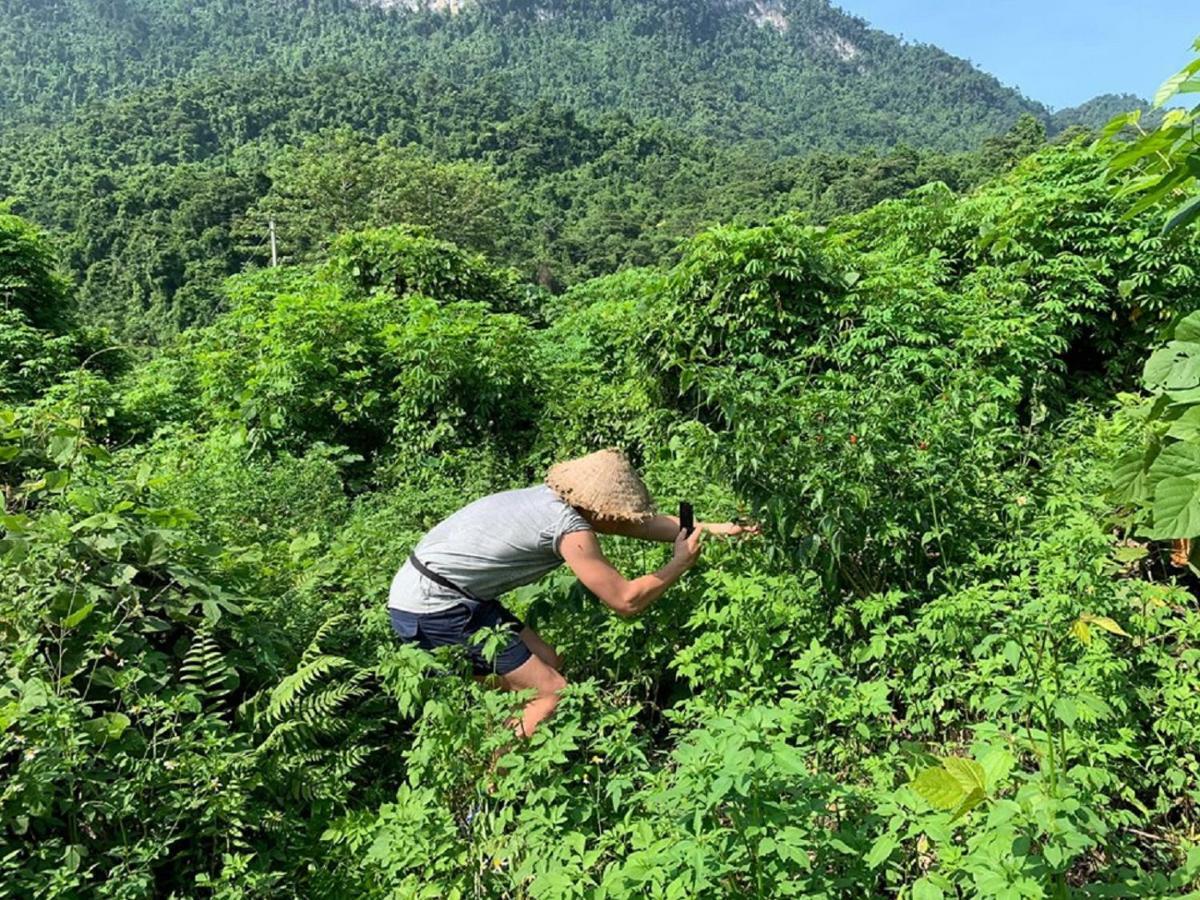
[0,73,1045,344]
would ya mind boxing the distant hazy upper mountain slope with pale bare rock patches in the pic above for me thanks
[0,0,1065,152]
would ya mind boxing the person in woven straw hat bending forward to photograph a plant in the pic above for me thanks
[388,449,758,736]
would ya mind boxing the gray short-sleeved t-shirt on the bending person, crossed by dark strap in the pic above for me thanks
[388,485,592,613]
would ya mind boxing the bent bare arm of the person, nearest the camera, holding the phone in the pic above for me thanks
[559,528,703,616]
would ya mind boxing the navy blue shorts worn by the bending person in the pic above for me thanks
[388,600,533,674]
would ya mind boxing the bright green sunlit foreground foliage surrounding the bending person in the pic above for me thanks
[0,103,1200,900]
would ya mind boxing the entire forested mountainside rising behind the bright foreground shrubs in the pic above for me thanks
[0,0,1089,344]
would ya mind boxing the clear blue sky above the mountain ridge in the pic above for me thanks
[833,0,1200,109]
